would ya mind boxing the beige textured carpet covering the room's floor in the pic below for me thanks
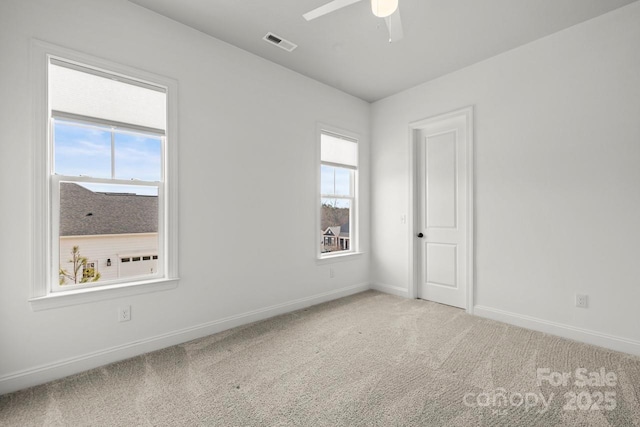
[0,291,640,427]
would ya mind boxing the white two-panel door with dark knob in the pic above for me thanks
[415,110,472,308]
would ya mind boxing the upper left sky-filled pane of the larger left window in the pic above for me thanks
[53,120,111,178]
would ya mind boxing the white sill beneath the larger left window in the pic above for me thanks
[29,278,179,311]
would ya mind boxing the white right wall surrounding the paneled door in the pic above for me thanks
[371,2,640,354]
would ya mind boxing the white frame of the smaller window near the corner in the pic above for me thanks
[314,123,361,263]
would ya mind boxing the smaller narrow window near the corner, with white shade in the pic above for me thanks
[320,130,358,257]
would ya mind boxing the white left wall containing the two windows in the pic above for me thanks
[0,0,370,393]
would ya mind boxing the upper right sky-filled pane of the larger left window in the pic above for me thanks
[114,133,162,182]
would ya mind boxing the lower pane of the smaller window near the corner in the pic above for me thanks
[320,198,351,253]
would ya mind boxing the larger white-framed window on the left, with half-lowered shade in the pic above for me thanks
[32,41,177,305]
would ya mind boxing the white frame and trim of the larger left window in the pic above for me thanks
[29,40,179,310]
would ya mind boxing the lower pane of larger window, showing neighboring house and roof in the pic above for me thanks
[59,182,159,285]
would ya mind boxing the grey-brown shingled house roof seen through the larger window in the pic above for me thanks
[60,182,158,236]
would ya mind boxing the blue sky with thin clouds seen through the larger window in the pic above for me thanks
[54,120,162,194]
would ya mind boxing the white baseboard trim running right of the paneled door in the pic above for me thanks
[473,305,640,356]
